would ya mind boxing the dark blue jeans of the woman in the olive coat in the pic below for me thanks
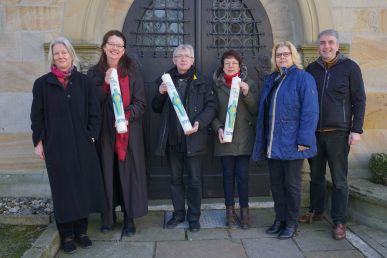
[220,155,250,208]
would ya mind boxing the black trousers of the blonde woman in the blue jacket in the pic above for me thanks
[268,159,304,226]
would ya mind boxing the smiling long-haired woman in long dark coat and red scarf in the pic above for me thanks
[87,30,148,236]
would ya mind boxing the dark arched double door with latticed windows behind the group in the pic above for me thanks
[123,0,273,199]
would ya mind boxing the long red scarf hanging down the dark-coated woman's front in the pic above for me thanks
[103,72,131,160]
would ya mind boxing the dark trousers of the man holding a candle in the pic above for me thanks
[167,151,203,221]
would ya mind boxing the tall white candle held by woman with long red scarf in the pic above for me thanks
[110,69,128,133]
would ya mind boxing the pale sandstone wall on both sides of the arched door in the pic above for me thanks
[0,0,387,175]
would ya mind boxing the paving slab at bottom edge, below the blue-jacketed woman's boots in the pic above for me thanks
[242,238,303,258]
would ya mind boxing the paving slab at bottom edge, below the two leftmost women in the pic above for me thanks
[57,241,155,258]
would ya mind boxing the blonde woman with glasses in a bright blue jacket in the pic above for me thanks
[253,41,318,239]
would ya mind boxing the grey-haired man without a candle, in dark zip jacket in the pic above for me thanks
[299,29,366,240]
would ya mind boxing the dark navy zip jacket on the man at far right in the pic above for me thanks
[306,54,366,133]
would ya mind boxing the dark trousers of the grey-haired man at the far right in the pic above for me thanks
[309,131,349,224]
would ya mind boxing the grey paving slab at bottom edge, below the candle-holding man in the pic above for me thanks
[155,240,247,258]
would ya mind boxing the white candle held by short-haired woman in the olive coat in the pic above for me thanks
[223,76,241,142]
